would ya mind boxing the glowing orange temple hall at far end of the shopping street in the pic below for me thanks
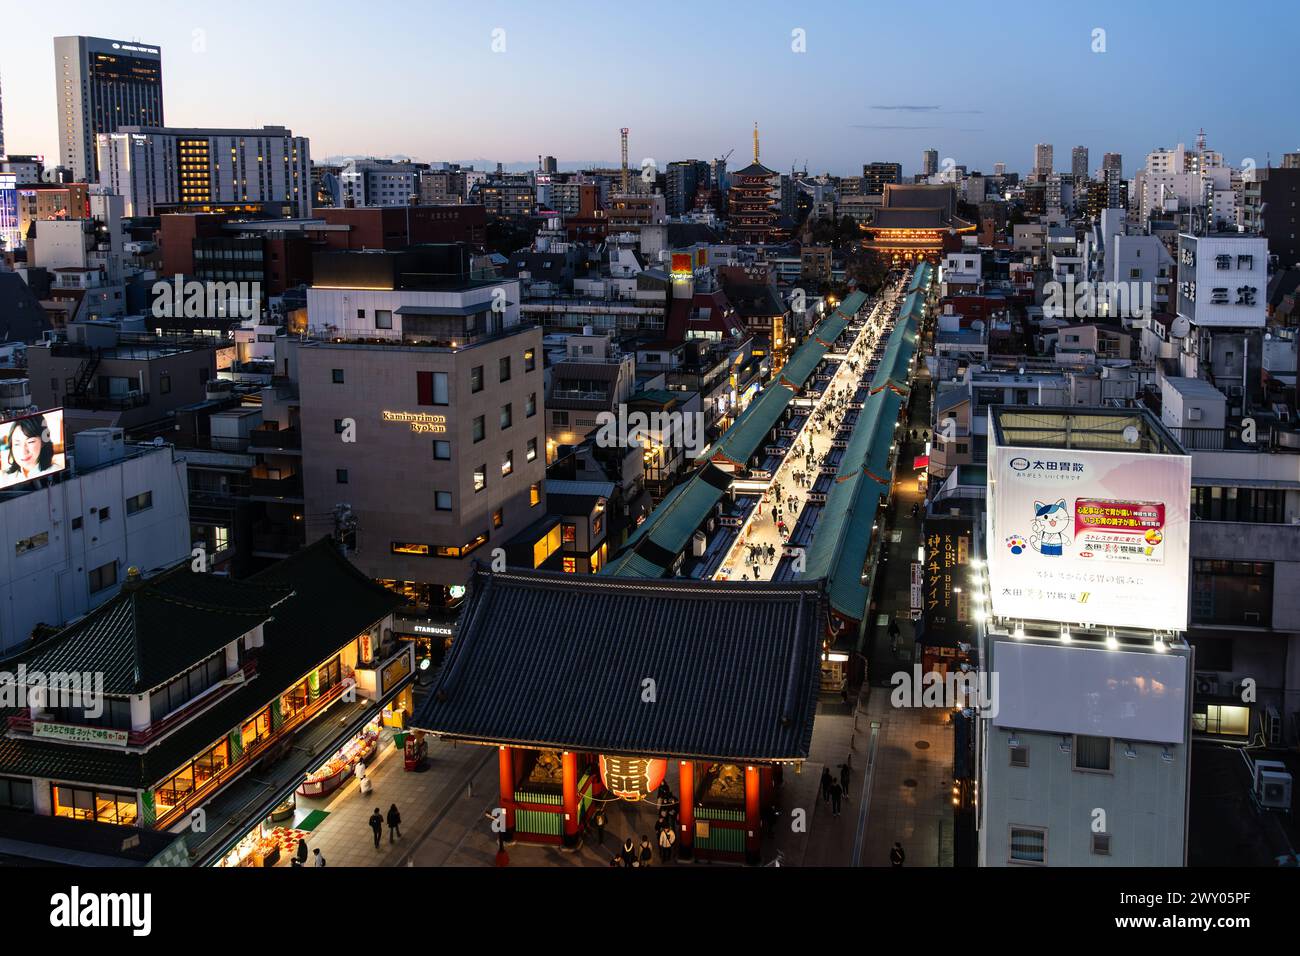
[862,185,976,264]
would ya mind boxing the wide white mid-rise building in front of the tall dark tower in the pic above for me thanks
[98,126,312,217]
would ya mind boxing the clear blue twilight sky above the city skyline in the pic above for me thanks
[0,0,1300,176]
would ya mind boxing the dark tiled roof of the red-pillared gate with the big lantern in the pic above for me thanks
[412,570,826,760]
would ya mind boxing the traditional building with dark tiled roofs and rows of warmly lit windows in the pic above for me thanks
[0,540,415,866]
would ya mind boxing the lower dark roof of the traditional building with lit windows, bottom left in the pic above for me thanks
[0,538,402,788]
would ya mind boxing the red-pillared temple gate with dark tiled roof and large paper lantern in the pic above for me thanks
[412,570,827,864]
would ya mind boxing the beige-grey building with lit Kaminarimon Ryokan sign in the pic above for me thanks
[297,246,543,607]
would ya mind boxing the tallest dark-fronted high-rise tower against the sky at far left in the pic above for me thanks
[55,36,164,182]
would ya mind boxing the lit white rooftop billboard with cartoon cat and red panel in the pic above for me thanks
[988,441,1192,631]
